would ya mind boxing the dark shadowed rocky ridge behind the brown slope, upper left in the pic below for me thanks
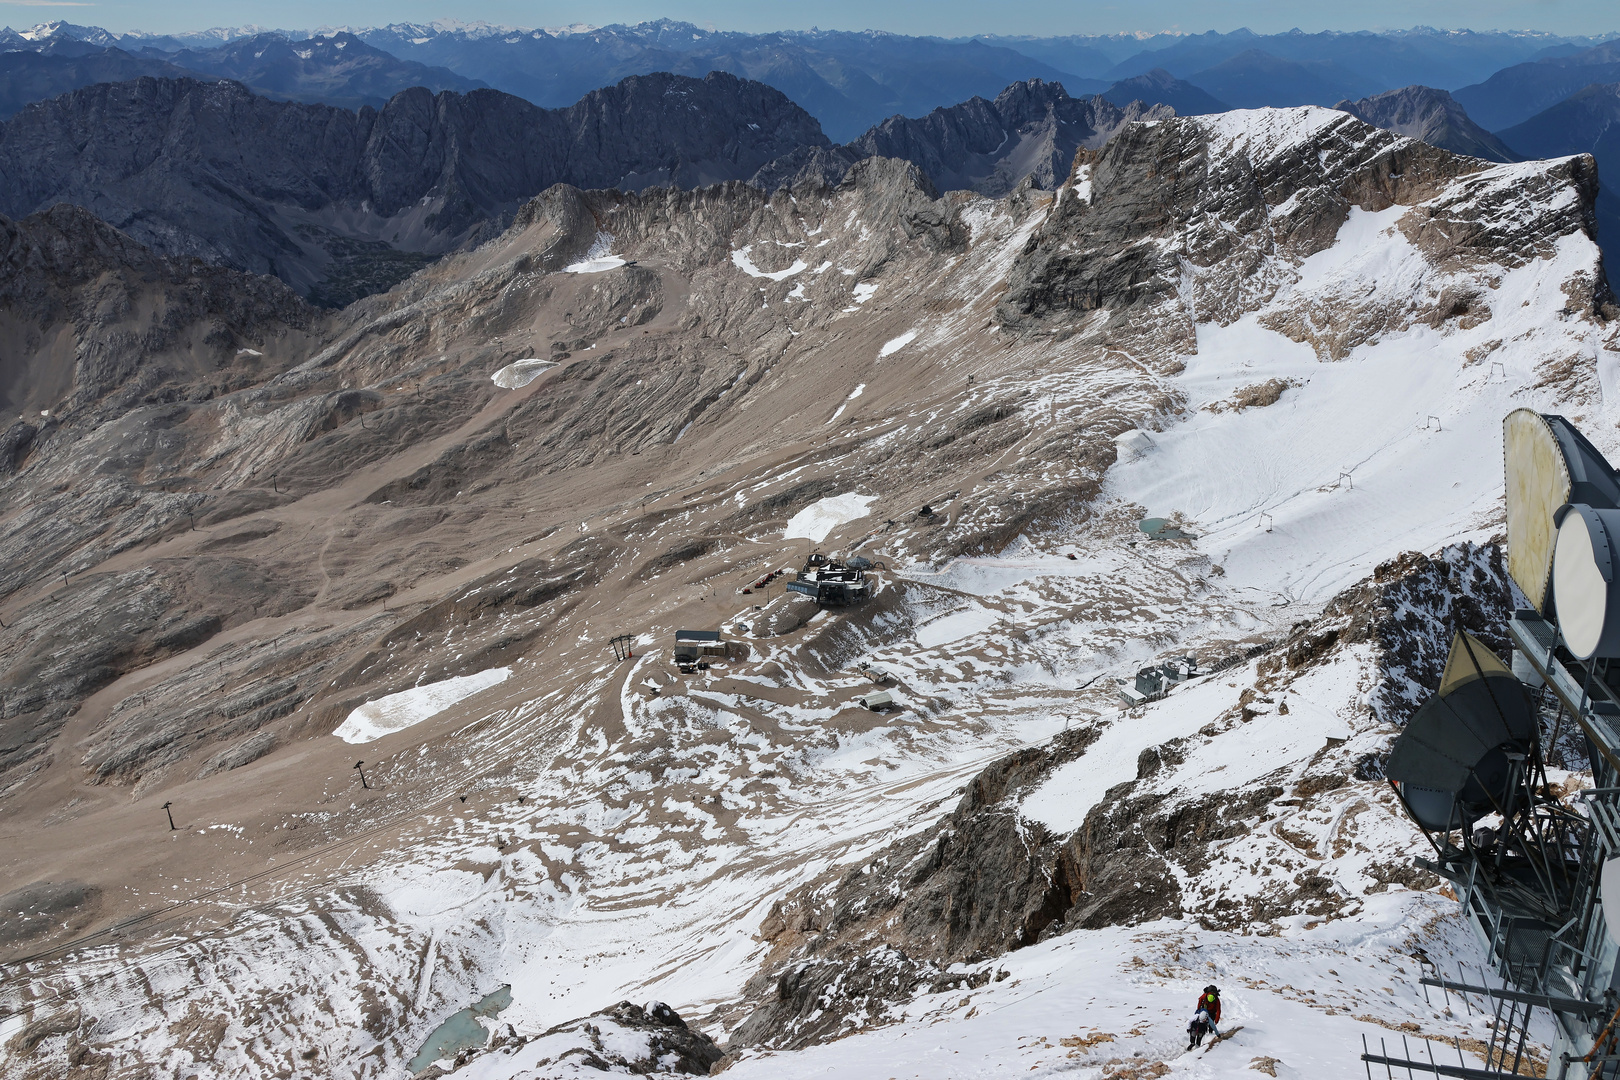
[0,73,826,303]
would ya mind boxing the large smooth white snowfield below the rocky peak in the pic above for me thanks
[1110,206,1591,602]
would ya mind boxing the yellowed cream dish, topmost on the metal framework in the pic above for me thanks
[1502,408,1620,615]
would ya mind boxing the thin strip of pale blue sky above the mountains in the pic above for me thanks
[0,0,1620,36]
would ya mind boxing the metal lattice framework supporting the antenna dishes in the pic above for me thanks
[1361,610,1620,1080]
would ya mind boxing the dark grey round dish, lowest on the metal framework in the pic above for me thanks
[1383,633,1536,832]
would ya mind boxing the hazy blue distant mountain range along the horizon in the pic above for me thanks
[0,19,1617,141]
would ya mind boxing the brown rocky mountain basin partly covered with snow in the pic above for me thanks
[0,108,1620,1077]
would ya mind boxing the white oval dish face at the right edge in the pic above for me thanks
[1552,504,1620,661]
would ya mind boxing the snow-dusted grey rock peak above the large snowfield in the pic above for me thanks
[998,108,1607,359]
